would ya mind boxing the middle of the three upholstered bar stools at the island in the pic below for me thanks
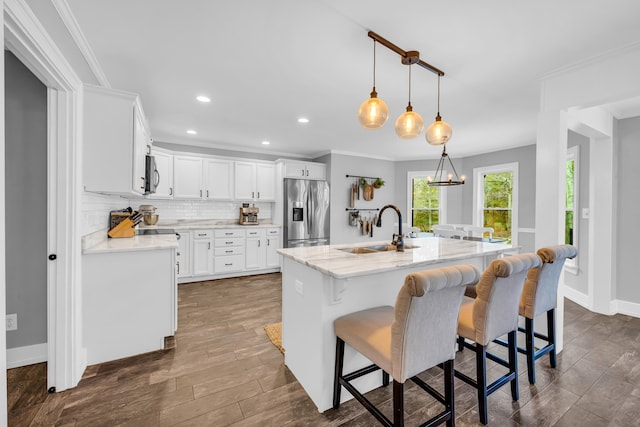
[455,253,542,424]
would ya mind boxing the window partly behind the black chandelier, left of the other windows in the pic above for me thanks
[407,172,446,231]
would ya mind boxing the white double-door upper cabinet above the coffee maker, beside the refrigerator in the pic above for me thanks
[234,161,276,202]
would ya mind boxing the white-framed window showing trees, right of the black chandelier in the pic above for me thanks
[473,163,518,245]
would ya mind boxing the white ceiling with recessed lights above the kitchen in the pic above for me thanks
[66,0,640,160]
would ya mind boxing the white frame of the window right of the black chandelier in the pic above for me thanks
[473,162,520,247]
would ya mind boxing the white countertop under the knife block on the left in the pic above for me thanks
[82,230,178,255]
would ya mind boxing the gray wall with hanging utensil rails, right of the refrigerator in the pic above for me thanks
[328,154,398,244]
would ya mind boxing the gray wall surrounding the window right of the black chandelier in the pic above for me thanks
[461,145,536,252]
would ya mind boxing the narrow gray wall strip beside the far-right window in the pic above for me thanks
[564,131,589,295]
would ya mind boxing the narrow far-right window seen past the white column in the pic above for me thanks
[564,145,579,274]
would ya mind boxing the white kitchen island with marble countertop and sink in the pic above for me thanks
[278,237,515,412]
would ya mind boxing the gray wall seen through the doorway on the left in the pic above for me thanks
[5,51,47,349]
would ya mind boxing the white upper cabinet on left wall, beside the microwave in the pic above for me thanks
[82,85,151,195]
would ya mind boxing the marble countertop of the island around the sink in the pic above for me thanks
[278,237,515,279]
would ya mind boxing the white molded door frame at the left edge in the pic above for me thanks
[0,0,86,391]
